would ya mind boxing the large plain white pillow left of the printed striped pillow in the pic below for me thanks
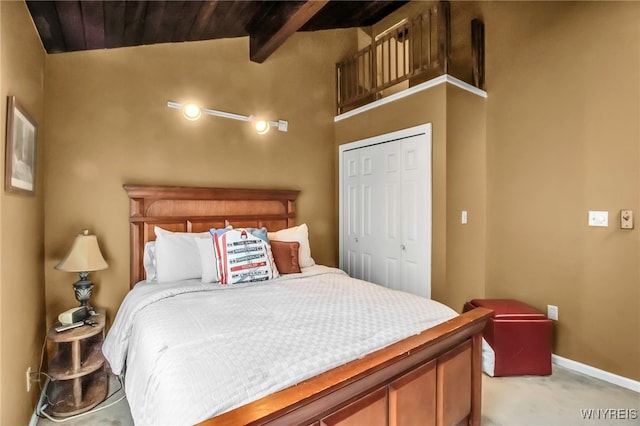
[154,226,211,282]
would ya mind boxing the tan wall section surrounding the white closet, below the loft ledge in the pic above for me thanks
[336,84,486,311]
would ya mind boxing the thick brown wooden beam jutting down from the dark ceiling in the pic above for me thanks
[249,0,329,64]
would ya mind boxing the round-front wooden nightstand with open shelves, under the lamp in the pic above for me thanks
[46,309,109,417]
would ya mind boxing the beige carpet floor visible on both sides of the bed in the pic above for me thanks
[37,365,640,426]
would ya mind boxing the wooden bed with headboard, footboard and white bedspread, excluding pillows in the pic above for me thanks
[103,185,491,426]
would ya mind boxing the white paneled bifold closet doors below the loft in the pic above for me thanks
[341,125,431,297]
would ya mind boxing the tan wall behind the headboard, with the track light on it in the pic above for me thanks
[45,30,356,326]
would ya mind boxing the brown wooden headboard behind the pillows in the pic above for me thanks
[123,185,300,287]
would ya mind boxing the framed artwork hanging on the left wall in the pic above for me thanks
[4,96,38,194]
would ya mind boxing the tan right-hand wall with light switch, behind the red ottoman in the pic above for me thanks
[483,2,640,380]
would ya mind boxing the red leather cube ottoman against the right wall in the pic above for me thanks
[464,299,553,376]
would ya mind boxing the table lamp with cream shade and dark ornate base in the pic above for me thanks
[55,229,109,311]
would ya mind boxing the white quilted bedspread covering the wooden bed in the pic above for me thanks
[103,266,457,425]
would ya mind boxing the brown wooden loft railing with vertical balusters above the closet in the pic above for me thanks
[336,1,484,114]
